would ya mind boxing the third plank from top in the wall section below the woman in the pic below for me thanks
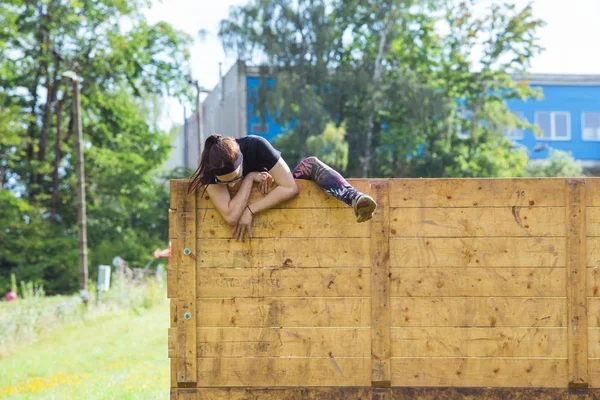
[197,238,371,268]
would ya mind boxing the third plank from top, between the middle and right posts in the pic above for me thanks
[390,238,564,267]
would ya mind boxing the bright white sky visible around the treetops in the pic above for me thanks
[145,0,600,128]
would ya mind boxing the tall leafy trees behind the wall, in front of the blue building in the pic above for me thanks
[220,0,543,177]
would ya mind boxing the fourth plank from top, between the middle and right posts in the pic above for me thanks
[391,268,568,297]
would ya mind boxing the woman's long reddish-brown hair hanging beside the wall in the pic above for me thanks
[188,135,240,193]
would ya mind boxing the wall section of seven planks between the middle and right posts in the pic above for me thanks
[390,179,568,387]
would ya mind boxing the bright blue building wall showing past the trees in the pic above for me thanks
[247,76,600,161]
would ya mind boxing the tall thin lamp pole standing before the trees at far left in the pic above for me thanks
[62,63,88,306]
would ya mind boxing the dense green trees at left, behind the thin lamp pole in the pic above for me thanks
[0,0,192,294]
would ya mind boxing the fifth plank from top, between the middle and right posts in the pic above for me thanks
[391,297,567,327]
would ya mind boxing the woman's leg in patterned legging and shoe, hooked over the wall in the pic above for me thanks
[292,157,377,222]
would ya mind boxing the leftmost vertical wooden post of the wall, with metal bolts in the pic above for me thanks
[173,182,197,388]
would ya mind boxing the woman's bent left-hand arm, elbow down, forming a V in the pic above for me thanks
[206,172,257,226]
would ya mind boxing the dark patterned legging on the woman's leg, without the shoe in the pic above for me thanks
[292,157,361,207]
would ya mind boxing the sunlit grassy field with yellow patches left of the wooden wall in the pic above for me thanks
[0,296,169,400]
